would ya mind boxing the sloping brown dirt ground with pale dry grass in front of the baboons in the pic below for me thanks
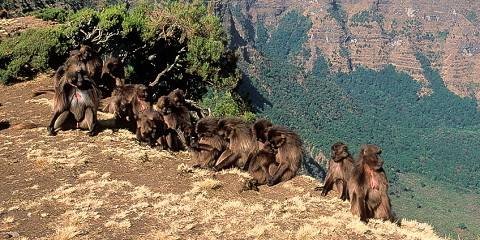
[0,75,438,239]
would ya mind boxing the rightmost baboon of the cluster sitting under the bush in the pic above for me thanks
[155,96,194,149]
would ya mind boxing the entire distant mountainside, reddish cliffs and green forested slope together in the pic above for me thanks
[218,0,480,238]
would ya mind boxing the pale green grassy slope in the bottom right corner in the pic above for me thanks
[390,173,480,239]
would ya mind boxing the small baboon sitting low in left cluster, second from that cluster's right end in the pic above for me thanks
[136,109,168,150]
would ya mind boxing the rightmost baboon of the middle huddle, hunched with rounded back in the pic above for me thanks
[266,126,303,186]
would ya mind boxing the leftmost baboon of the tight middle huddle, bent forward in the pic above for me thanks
[190,117,228,168]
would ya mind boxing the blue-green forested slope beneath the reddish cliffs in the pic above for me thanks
[243,11,480,238]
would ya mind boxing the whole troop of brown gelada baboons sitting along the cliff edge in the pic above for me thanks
[34,46,393,222]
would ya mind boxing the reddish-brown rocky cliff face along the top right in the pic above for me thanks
[220,0,480,100]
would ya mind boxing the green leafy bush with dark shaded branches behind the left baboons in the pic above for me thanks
[0,1,251,115]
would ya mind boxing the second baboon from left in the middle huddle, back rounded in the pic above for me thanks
[214,118,258,171]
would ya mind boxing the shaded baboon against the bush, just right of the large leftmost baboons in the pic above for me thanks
[100,57,125,97]
